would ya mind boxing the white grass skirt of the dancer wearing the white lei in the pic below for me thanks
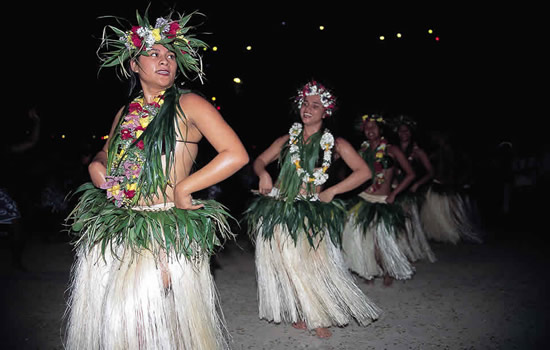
[256,226,381,329]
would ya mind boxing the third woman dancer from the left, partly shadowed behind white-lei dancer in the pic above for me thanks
[342,114,415,286]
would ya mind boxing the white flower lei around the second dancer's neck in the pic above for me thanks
[288,123,334,186]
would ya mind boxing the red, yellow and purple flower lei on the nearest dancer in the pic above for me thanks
[101,92,164,207]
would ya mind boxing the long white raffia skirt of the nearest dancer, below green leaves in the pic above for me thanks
[65,202,229,350]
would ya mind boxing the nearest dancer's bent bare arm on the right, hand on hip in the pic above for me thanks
[174,94,248,209]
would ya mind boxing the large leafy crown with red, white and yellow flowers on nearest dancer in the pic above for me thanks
[98,11,208,82]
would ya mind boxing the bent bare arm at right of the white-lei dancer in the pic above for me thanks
[319,137,372,202]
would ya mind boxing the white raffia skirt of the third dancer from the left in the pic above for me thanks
[342,192,414,280]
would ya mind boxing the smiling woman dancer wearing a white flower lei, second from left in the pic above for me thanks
[245,81,380,337]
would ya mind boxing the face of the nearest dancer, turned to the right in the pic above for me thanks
[130,44,178,90]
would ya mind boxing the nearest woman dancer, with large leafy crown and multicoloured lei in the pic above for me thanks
[65,8,248,350]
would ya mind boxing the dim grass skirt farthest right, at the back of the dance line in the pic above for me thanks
[420,187,482,244]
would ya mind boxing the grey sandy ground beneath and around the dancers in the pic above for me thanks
[0,226,550,350]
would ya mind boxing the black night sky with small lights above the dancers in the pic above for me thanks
[4,1,542,165]
